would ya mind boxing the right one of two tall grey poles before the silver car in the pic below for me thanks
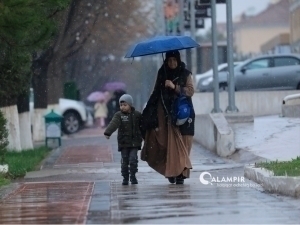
[226,0,238,112]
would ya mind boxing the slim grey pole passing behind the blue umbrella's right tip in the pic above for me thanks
[190,0,197,86]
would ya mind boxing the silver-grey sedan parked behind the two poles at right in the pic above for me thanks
[198,54,300,92]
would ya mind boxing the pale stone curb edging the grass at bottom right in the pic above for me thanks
[244,164,300,198]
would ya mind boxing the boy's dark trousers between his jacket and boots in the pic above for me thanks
[121,148,138,178]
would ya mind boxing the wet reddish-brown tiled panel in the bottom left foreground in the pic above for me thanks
[0,182,94,224]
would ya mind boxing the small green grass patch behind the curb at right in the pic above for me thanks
[255,156,300,177]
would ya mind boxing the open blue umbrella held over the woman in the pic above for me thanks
[125,36,200,58]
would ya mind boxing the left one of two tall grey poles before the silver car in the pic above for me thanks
[210,0,221,113]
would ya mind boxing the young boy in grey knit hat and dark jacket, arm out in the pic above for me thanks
[104,94,142,185]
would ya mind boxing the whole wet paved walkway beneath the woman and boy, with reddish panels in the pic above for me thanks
[0,132,300,224]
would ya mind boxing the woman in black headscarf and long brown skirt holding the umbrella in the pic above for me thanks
[141,51,195,184]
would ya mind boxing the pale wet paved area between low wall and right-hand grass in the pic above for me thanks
[232,115,300,161]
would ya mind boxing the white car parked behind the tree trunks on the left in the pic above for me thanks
[29,89,88,134]
